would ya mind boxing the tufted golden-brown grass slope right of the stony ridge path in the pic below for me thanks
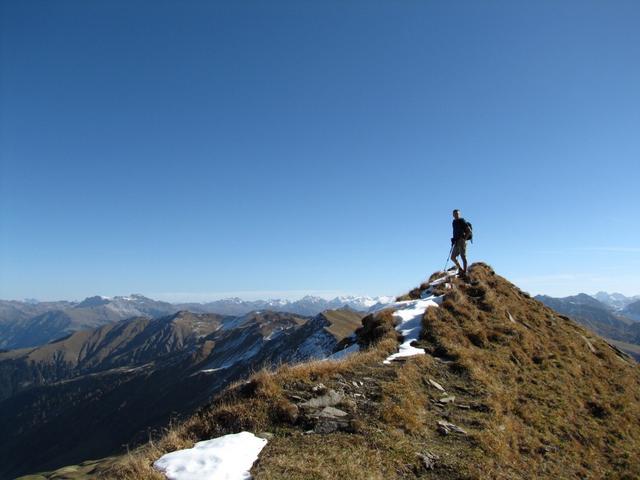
[423,264,640,478]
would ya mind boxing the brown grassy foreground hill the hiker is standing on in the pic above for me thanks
[43,264,640,480]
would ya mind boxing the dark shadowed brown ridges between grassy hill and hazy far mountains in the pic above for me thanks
[0,312,361,479]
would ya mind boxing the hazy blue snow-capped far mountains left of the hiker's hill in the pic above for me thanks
[0,294,393,350]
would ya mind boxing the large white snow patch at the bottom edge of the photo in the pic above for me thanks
[153,432,267,480]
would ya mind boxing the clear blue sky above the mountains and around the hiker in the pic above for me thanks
[0,0,640,300]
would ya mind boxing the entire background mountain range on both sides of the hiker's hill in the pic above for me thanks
[0,284,640,478]
